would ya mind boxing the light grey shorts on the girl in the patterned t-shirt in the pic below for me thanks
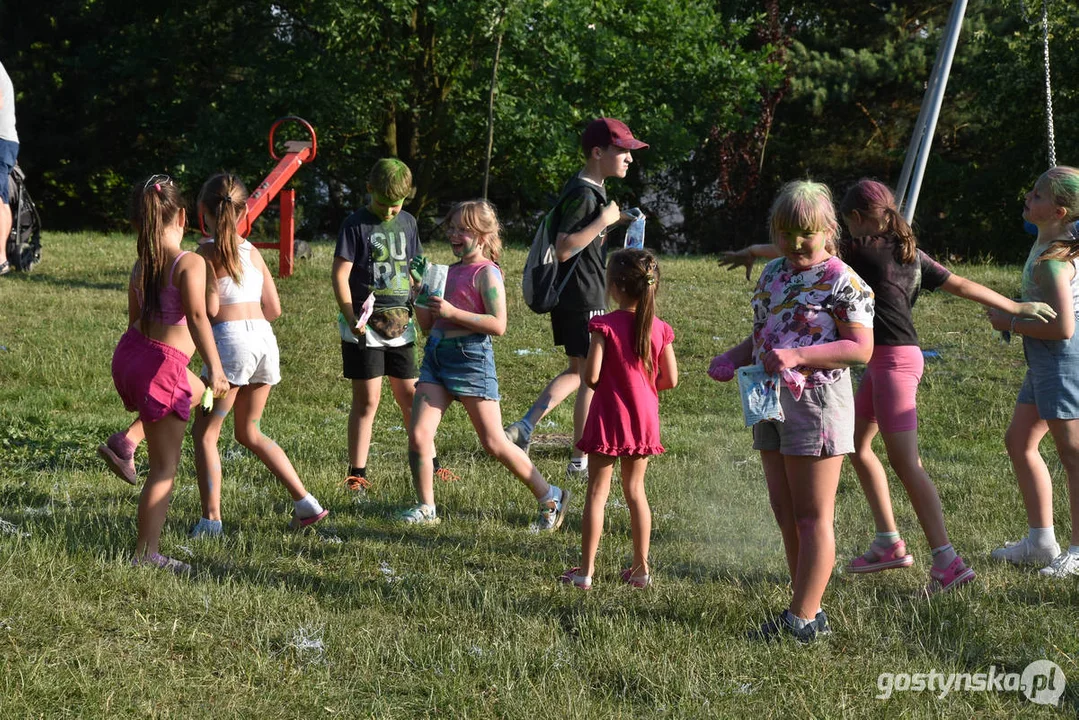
[753,372,855,458]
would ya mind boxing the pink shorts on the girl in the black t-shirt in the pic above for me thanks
[855,345,926,433]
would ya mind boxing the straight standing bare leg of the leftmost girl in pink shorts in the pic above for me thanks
[135,410,190,557]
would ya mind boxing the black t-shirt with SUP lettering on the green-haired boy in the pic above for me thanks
[333,207,423,312]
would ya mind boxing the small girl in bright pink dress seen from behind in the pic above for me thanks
[561,249,678,590]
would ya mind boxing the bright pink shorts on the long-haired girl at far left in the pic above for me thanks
[112,327,193,422]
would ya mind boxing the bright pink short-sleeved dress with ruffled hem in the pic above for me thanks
[577,310,674,457]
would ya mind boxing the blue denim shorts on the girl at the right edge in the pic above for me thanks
[1017,337,1079,420]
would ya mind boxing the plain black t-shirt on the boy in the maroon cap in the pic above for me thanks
[555,175,606,311]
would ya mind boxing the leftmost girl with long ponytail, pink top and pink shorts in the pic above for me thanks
[112,175,229,574]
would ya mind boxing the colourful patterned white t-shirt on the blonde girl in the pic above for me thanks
[753,257,873,388]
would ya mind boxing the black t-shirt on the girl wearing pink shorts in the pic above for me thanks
[839,233,952,347]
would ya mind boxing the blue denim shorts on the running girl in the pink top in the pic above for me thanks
[419,334,500,400]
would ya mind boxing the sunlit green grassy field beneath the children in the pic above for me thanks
[0,234,1079,718]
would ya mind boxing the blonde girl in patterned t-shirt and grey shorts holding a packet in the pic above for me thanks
[709,181,873,642]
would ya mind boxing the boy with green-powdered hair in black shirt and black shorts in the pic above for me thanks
[332,158,453,491]
